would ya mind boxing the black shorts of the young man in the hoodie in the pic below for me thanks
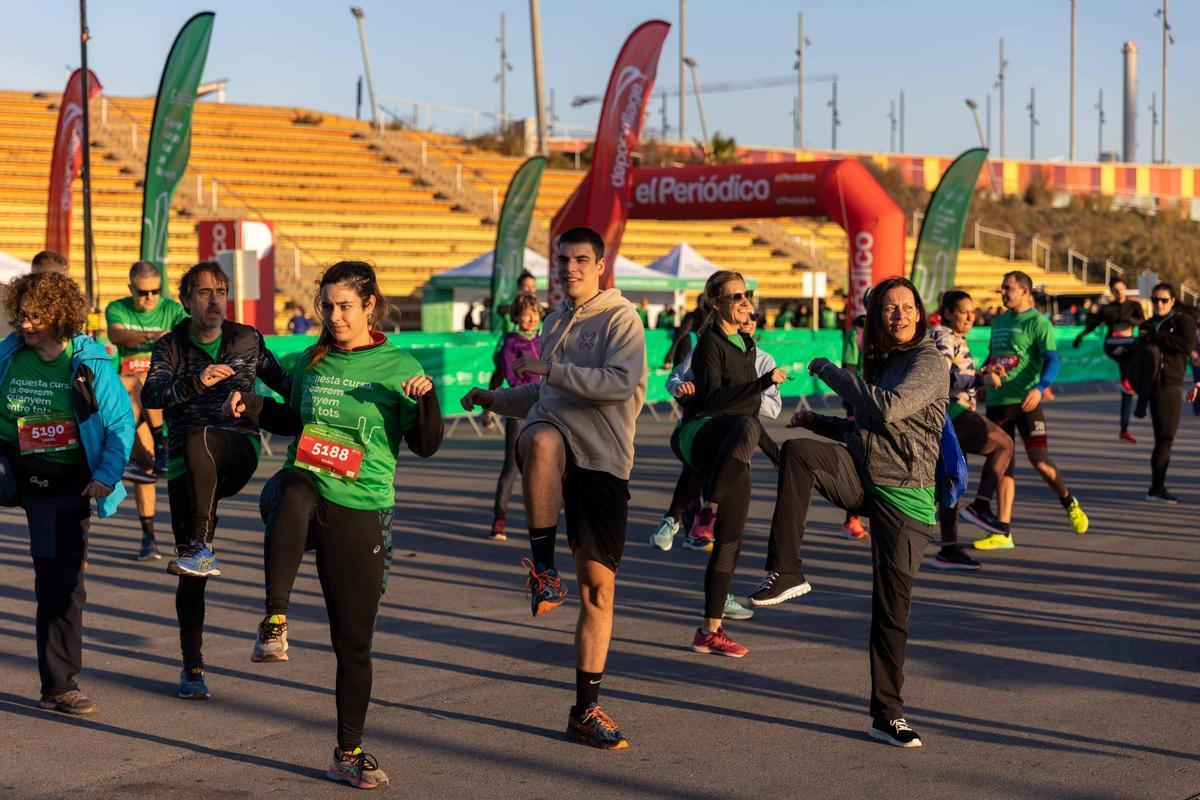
[518,422,629,572]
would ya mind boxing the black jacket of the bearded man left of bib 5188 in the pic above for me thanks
[142,319,292,457]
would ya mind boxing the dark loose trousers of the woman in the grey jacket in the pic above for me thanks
[767,439,934,720]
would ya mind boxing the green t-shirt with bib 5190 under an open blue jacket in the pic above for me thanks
[0,345,84,464]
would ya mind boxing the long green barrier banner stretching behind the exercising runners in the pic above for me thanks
[253,325,1118,416]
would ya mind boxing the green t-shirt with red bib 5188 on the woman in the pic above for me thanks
[287,344,425,511]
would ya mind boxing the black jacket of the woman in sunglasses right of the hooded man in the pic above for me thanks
[684,326,770,420]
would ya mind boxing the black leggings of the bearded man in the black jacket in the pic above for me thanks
[167,426,258,667]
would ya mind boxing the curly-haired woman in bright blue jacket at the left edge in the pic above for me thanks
[0,272,133,715]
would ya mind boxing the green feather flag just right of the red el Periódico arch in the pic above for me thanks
[912,148,988,312]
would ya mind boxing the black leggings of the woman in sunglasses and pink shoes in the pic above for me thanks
[671,416,762,619]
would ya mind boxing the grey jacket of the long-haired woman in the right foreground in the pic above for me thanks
[811,337,950,488]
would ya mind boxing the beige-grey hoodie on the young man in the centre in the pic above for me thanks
[492,289,647,481]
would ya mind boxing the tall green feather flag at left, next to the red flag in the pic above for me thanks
[140,11,215,291]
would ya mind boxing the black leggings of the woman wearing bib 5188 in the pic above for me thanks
[259,469,392,751]
